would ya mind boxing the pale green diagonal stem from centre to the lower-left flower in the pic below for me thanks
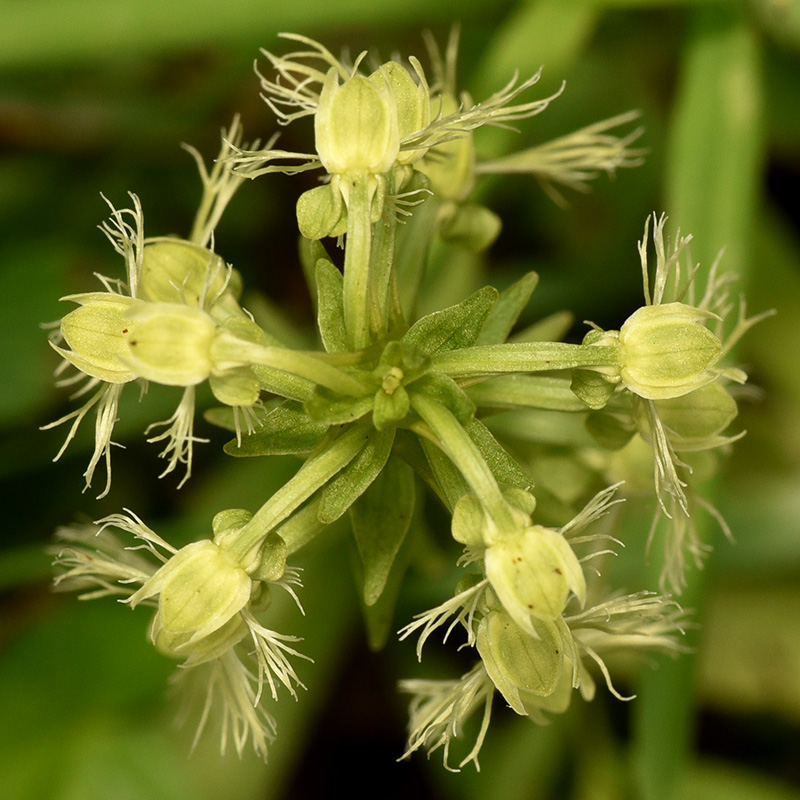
[230,425,371,559]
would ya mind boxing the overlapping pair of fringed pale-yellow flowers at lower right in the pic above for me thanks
[400,486,683,769]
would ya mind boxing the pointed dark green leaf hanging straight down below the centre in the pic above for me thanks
[350,456,415,606]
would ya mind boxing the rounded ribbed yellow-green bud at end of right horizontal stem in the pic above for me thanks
[619,303,722,400]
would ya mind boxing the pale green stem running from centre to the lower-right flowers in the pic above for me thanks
[411,392,516,531]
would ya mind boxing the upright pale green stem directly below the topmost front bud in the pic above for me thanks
[342,173,374,350]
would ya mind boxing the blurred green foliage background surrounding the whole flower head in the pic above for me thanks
[0,0,800,800]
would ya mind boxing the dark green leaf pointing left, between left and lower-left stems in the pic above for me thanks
[222,400,328,456]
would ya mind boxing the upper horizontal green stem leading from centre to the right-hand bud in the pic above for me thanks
[433,342,620,378]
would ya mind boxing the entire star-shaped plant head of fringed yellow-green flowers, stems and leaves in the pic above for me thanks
[45,35,758,765]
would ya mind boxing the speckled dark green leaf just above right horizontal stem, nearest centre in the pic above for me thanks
[403,286,499,355]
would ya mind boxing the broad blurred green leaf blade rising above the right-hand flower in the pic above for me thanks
[666,4,764,276]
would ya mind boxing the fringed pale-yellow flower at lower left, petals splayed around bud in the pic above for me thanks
[49,509,307,758]
